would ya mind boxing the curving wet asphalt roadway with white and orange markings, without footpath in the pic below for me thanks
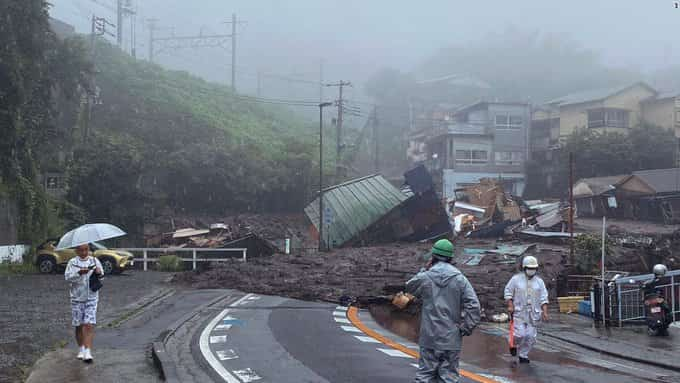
[183,295,678,383]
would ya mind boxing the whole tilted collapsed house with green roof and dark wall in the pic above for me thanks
[305,170,450,248]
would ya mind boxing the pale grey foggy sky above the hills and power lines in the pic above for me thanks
[51,0,680,100]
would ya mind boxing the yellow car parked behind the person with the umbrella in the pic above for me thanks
[36,238,134,274]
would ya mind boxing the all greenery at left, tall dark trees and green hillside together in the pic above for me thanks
[0,0,318,246]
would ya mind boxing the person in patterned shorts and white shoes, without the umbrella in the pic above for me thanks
[64,244,104,363]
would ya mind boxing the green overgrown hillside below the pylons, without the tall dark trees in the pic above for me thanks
[69,42,318,240]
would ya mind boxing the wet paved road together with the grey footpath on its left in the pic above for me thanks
[28,290,680,383]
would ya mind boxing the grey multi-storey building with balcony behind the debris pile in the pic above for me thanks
[426,101,531,199]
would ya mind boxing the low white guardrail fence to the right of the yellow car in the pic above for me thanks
[118,247,248,271]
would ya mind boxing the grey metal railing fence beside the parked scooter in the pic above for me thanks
[608,270,680,326]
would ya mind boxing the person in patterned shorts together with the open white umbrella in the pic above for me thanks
[57,224,125,363]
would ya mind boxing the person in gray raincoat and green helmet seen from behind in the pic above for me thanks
[406,239,480,383]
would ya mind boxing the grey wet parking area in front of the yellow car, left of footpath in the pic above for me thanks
[0,270,169,383]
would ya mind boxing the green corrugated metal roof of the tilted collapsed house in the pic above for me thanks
[305,175,407,246]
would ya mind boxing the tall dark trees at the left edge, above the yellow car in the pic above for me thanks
[0,0,90,242]
